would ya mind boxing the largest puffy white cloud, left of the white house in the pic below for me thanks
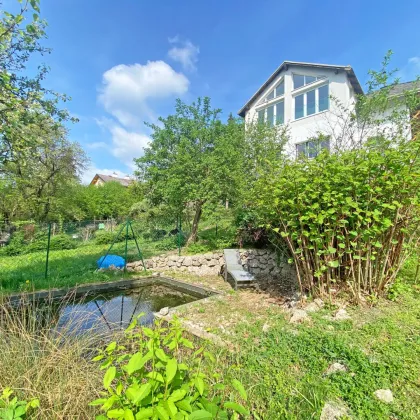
[98,61,190,127]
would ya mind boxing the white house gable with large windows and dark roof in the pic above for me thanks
[239,61,418,157]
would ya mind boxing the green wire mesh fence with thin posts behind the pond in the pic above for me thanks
[0,219,187,288]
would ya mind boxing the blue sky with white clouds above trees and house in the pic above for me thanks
[21,0,420,182]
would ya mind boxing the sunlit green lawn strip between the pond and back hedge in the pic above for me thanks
[0,241,167,293]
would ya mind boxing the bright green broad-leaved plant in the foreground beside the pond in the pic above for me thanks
[91,320,249,420]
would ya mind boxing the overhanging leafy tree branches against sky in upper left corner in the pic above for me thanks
[0,0,75,174]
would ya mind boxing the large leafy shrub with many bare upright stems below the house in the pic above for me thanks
[253,141,420,299]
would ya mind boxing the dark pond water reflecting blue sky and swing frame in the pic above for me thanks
[6,284,199,335]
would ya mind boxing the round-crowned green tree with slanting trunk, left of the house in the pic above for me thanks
[136,98,245,242]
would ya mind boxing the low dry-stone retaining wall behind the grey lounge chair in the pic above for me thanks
[127,249,296,279]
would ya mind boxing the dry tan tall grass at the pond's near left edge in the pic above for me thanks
[0,296,106,420]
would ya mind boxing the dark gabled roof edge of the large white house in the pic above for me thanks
[238,61,363,117]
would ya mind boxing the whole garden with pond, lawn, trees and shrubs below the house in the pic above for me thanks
[0,0,420,420]
